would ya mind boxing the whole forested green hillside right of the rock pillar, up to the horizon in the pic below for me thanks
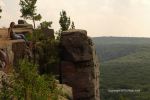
[94,37,150,100]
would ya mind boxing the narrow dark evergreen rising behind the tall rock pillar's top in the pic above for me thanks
[59,10,70,31]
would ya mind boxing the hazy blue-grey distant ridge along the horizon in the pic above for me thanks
[93,37,150,62]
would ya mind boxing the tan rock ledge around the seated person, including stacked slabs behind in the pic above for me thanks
[0,20,33,70]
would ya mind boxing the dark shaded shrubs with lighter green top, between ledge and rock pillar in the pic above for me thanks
[28,28,60,73]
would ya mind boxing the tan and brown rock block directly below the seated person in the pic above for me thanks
[0,39,27,72]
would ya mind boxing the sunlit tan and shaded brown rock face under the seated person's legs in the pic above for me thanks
[0,39,26,69]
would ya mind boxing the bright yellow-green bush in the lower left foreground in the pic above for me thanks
[16,60,55,100]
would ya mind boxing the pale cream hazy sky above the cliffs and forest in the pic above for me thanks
[0,0,150,37]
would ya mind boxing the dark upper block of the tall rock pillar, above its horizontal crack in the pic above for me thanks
[61,30,92,62]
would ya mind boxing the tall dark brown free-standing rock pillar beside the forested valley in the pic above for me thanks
[60,30,100,100]
